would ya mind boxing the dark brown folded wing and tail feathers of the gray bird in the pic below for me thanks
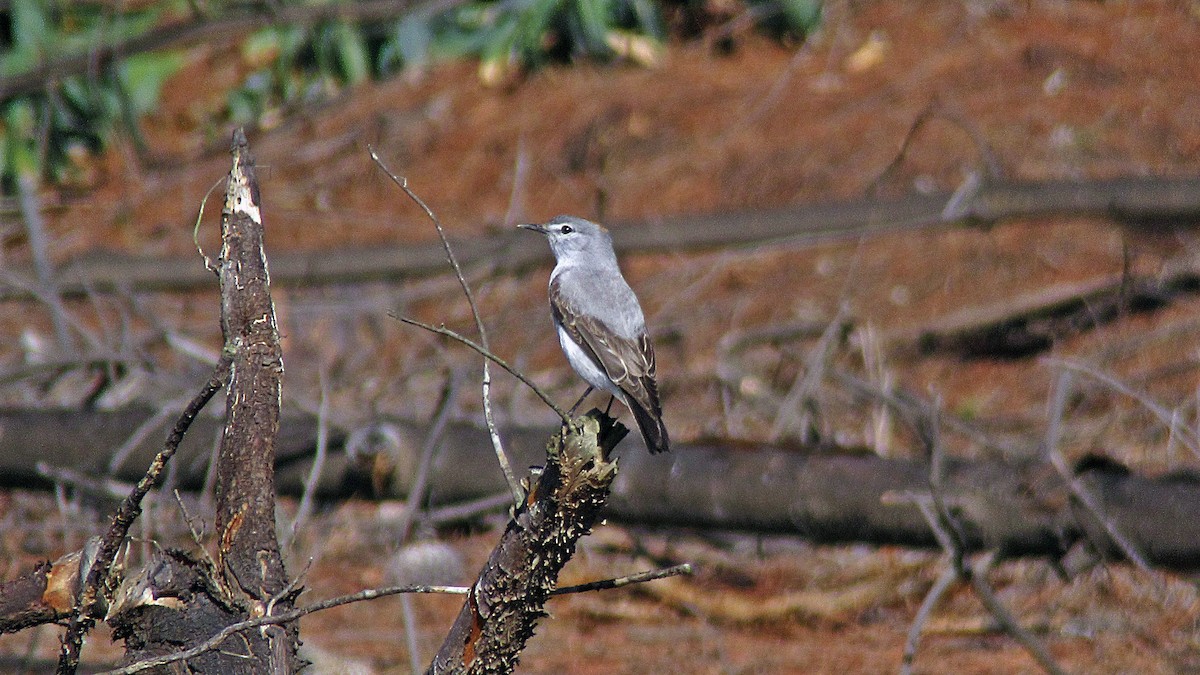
[550,282,671,453]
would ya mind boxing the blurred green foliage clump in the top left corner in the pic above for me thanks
[0,0,182,193]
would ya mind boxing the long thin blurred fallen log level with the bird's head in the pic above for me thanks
[7,175,1200,299]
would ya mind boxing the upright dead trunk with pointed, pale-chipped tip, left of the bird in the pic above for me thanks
[206,129,296,671]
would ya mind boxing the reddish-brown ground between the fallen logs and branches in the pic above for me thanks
[0,0,1200,674]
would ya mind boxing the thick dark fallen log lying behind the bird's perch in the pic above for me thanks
[7,410,1200,571]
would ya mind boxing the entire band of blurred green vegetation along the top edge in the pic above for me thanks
[0,0,821,195]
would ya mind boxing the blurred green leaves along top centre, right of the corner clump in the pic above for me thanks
[229,0,821,125]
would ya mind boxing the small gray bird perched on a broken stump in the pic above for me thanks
[517,216,671,453]
